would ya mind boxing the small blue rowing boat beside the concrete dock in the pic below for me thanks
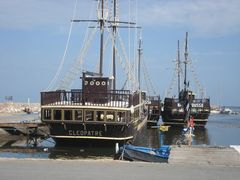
[119,144,171,163]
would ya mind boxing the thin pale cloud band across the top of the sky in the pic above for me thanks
[0,0,240,36]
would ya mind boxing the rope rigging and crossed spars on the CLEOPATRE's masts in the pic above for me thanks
[47,0,149,91]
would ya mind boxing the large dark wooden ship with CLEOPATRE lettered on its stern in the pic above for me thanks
[41,0,160,146]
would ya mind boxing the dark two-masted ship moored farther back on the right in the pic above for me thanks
[161,33,210,126]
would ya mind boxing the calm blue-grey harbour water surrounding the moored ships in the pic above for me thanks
[0,107,240,159]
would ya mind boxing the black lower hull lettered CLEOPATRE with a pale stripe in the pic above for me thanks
[46,120,146,146]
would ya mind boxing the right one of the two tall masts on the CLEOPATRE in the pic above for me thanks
[112,0,117,90]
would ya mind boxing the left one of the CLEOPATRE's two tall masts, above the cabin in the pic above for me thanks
[99,0,104,76]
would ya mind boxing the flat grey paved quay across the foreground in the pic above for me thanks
[0,159,240,180]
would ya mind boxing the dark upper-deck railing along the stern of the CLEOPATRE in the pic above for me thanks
[41,90,133,107]
